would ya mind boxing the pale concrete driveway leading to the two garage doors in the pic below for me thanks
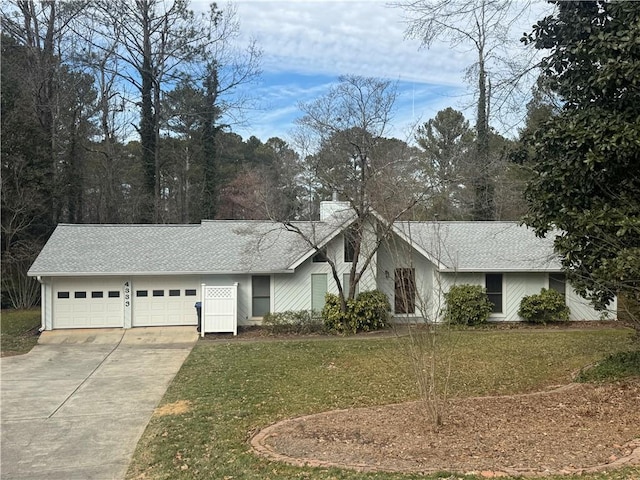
[0,327,197,480]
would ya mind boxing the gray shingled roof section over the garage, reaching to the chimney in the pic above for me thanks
[29,220,342,276]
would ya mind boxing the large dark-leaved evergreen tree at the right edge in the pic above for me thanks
[523,1,640,329]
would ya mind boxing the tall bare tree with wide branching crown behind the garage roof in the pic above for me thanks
[75,0,256,222]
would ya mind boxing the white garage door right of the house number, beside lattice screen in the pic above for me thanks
[131,277,200,327]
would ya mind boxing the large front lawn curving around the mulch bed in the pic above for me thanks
[127,329,640,480]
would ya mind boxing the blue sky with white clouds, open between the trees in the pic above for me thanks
[208,0,548,145]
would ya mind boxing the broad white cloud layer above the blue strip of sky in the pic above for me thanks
[237,0,470,86]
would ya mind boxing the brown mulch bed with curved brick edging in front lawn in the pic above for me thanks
[251,379,640,476]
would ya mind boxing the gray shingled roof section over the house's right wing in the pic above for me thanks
[396,222,560,272]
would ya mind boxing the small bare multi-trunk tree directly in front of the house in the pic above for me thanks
[285,76,419,311]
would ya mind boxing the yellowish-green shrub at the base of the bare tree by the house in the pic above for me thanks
[322,290,391,334]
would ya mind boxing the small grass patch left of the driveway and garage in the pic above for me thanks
[0,308,40,356]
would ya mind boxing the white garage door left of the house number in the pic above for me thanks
[53,278,124,328]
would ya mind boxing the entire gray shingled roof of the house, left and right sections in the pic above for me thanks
[29,217,560,276]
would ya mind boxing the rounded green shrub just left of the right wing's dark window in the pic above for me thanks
[444,284,493,325]
